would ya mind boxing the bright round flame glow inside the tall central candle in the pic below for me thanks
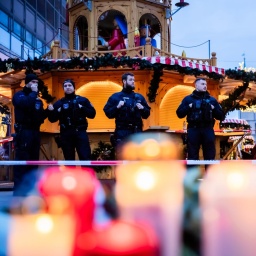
[135,166,156,190]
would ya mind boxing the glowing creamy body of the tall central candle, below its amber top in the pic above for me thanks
[116,161,184,256]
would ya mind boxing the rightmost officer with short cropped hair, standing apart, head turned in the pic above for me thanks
[176,78,224,160]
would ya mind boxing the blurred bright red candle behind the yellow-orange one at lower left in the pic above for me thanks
[38,167,97,256]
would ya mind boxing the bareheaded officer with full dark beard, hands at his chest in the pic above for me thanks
[103,73,150,153]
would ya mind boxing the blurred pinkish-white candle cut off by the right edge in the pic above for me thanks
[200,161,256,256]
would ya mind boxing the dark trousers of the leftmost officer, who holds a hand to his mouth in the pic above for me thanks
[13,128,40,196]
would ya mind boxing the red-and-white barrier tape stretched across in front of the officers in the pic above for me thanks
[0,160,256,166]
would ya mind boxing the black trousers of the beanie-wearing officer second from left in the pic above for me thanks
[60,128,91,160]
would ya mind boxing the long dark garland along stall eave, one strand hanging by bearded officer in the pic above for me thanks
[0,54,223,102]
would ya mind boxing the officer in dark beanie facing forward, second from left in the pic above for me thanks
[48,79,96,160]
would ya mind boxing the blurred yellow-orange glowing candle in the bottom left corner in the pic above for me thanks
[6,213,74,256]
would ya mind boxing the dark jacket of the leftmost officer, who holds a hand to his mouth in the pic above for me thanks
[12,86,47,129]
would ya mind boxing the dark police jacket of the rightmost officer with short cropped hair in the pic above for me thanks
[176,90,224,128]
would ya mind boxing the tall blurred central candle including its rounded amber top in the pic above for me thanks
[115,133,185,256]
